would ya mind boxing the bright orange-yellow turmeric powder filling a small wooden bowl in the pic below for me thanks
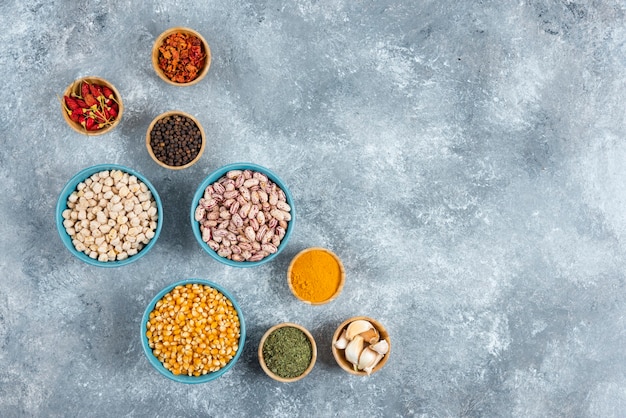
[289,248,344,303]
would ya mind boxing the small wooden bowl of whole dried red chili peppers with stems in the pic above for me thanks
[61,77,124,136]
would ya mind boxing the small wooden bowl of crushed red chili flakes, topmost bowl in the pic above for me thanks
[152,27,211,86]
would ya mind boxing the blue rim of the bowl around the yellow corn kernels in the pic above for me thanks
[141,279,246,383]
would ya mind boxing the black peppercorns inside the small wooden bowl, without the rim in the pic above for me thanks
[150,115,202,167]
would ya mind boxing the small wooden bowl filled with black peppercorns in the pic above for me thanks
[146,110,206,170]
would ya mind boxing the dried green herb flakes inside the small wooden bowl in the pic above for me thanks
[263,327,313,379]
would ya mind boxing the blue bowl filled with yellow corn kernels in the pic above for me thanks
[141,279,246,383]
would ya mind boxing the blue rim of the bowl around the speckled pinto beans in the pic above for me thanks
[190,163,296,267]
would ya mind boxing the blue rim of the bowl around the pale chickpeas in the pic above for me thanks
[55,164,163,267]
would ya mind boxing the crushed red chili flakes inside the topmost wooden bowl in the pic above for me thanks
[159,32,206,83]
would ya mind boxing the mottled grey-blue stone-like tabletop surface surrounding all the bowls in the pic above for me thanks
[0,0,626,417]
